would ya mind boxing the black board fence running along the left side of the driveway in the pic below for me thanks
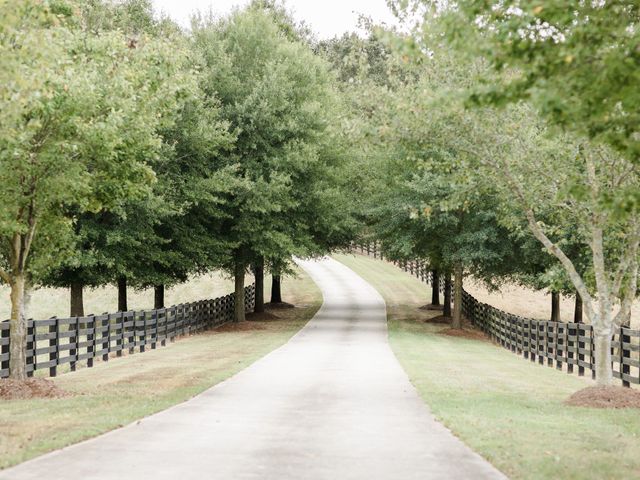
[0,285,255,378]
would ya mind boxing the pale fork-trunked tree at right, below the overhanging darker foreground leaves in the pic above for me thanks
[482,109,640,385]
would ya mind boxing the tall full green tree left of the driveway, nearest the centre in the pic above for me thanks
[194,2,352,321]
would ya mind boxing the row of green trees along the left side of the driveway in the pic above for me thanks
[0,0,355,378]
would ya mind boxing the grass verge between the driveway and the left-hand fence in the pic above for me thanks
[0,268,322,468]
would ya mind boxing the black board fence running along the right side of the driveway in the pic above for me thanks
[353,244,640,387]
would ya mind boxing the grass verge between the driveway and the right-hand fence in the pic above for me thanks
[336,255,640,479]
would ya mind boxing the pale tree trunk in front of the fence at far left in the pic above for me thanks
[9,275,27,380]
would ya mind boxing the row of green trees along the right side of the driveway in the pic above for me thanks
[342,0,640,385]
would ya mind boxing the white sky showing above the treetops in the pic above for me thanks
[153,0,396,39]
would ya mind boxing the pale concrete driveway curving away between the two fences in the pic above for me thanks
[0,259,504,480]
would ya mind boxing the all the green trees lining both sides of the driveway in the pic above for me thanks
[0,0,640,384]
